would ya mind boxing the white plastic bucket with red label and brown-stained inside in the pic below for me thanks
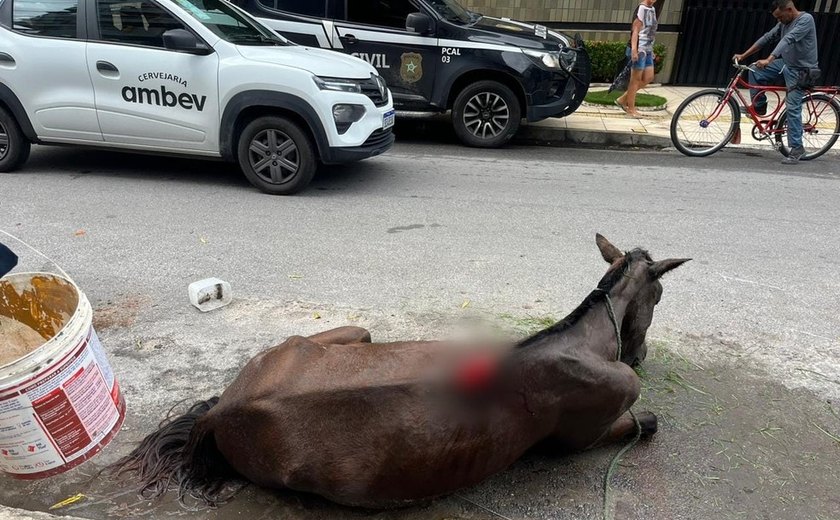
[0,273,125,479]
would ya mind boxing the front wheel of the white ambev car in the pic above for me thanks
[237,116,317,195]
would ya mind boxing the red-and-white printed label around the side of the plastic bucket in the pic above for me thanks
[0,327,121,475]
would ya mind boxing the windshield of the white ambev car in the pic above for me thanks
[170,0,292,45]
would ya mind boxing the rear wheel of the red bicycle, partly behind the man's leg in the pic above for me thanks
[776,94,840,161]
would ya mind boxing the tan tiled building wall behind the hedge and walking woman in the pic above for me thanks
[461,0,683,83]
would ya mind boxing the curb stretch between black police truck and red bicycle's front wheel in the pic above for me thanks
[514,125,672,149]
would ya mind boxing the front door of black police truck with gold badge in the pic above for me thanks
[333,0,441,110]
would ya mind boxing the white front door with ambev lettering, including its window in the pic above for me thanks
[87,0,219,152]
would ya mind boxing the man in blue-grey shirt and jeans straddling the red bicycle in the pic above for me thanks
[733,0,819,164]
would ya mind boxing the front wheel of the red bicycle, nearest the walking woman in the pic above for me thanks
[671,89,741,157]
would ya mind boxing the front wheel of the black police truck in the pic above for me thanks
[452,81,522,148]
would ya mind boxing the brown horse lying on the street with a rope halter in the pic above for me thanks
[112,235,686,507]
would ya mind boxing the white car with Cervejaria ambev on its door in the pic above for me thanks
[0,0,394,194]
